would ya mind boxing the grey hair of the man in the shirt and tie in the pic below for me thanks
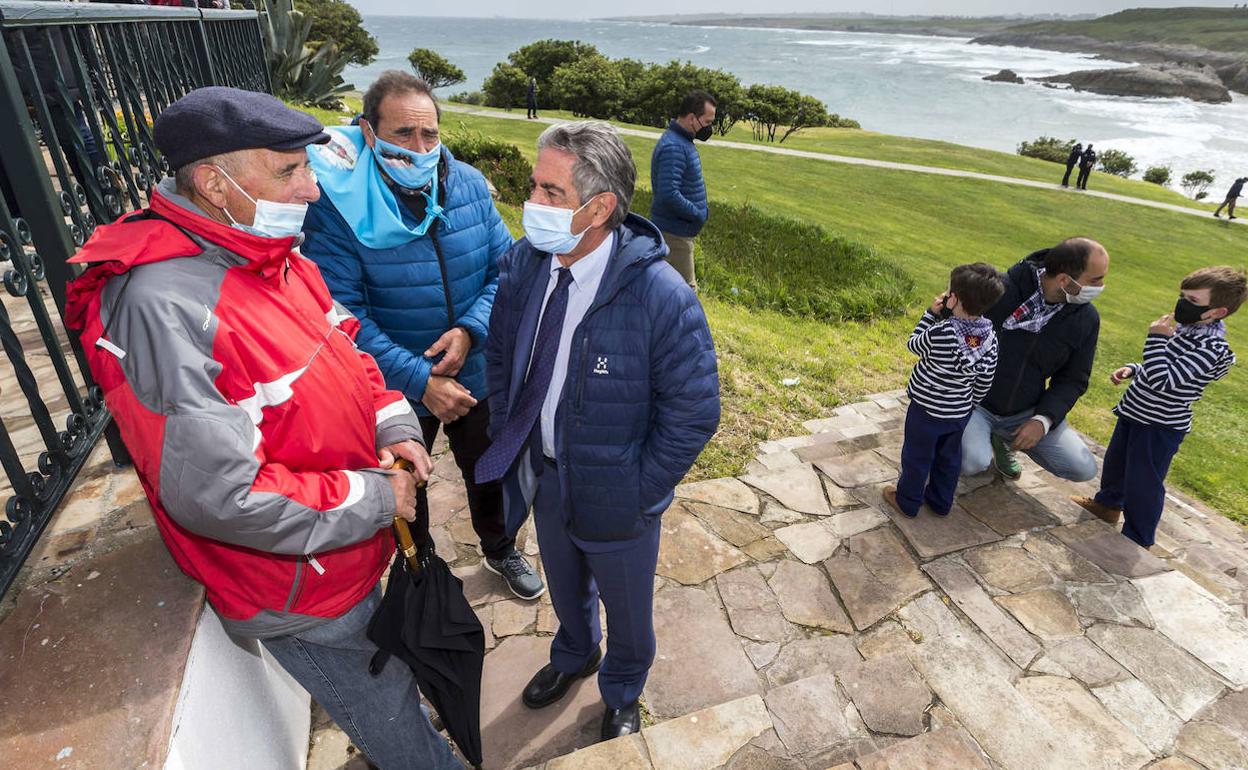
[538,120,636,227]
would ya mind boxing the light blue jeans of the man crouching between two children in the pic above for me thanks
[962,407,1096,482]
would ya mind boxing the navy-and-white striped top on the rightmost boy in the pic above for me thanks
[1113,323,1236,432]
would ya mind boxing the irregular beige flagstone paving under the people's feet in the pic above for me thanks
[310,392,1248,770]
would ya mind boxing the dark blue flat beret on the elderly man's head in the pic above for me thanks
[152,86,329,171]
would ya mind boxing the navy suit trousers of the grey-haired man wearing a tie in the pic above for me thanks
[533,461,661,709]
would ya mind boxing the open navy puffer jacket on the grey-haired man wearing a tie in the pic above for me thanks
[485,215,719,542]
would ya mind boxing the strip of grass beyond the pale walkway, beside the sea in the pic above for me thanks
[446,105,1214,212]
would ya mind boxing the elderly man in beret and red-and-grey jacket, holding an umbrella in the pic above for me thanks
[66,87,461,770]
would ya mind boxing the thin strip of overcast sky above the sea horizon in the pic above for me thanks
[348,0,1236,19]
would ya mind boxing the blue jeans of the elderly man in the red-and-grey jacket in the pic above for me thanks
[261,588,463,770]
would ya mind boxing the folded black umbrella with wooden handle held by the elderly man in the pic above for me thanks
[368,461,485,768]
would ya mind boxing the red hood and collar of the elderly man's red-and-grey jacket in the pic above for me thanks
[65,178,297,328]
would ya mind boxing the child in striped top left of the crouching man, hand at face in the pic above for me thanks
[884,262,1005,518]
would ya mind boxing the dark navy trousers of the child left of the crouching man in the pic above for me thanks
[897,402,971,515]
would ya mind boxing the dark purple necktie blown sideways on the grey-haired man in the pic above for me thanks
[474,267,572,484]
